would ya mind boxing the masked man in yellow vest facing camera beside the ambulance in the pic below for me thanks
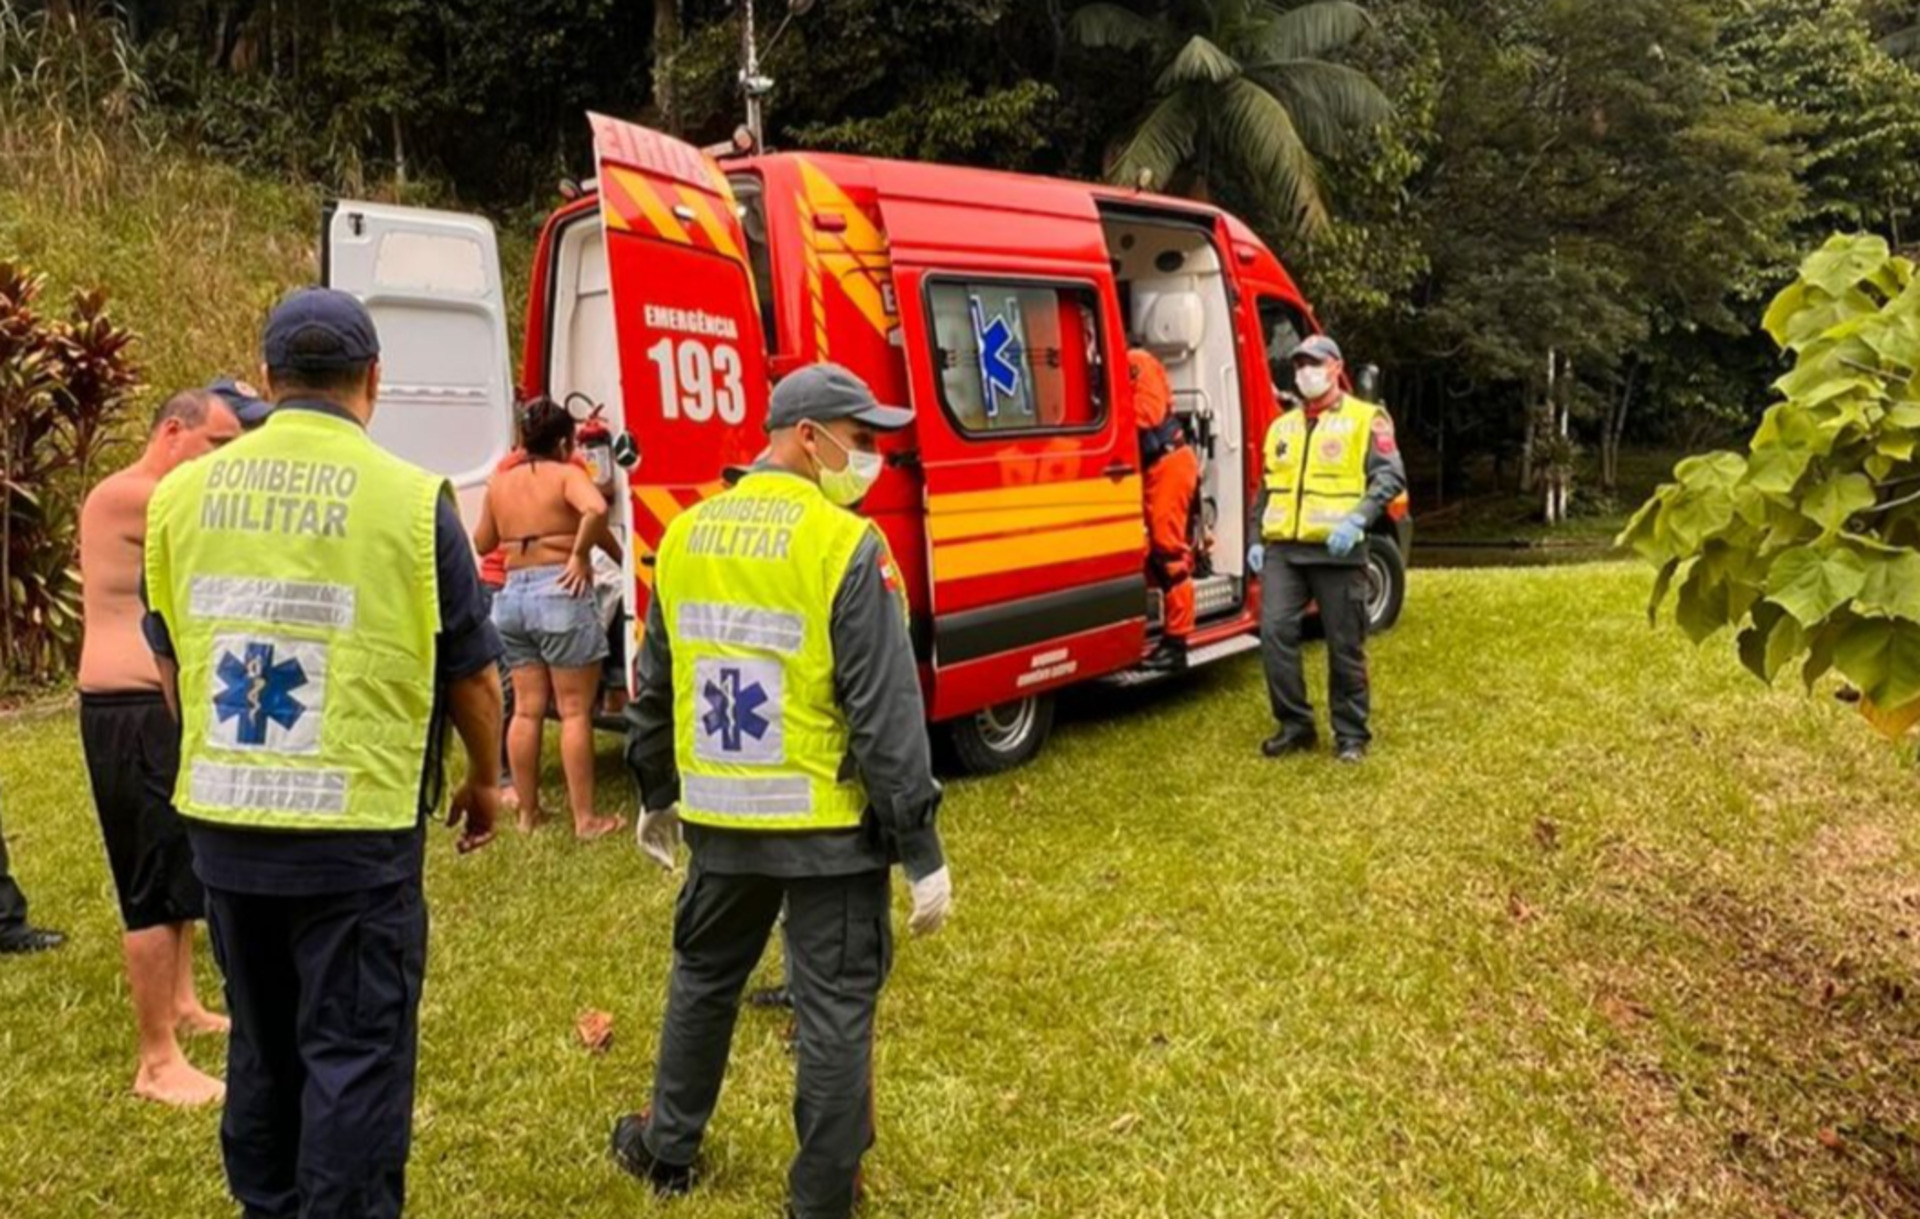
[1246,334,1407,762]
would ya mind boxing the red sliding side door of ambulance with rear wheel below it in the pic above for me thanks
[876,165,1146,770]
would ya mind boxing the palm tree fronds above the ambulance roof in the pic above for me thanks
[1068,0,1392,234]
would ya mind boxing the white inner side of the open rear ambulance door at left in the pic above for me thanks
[321,200,513,528]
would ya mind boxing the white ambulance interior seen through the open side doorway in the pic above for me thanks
[1102,215,1248,620]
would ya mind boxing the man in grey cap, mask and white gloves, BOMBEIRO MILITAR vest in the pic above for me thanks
[612,365,952,1219]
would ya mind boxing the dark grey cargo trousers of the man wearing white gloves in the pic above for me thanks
[647,860,893,1219]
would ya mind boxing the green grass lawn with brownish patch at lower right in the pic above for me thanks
[0,566,1920,1219]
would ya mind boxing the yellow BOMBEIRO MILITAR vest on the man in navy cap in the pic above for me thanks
[146,409,451,831]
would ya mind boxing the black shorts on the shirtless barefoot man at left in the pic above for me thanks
[81,691,207,931]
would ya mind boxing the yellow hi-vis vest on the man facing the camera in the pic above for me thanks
[1260,395,1380,541]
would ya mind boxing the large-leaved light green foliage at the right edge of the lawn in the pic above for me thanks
[1620,236,1920,731]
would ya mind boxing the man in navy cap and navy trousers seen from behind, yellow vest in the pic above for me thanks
[146,288,499,1219]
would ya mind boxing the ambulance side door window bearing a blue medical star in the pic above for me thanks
[927,280,1106,436]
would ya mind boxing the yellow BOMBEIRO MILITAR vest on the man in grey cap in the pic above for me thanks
[653,470,879,831]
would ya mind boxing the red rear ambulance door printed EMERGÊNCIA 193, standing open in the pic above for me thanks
[589,115,783,680]
